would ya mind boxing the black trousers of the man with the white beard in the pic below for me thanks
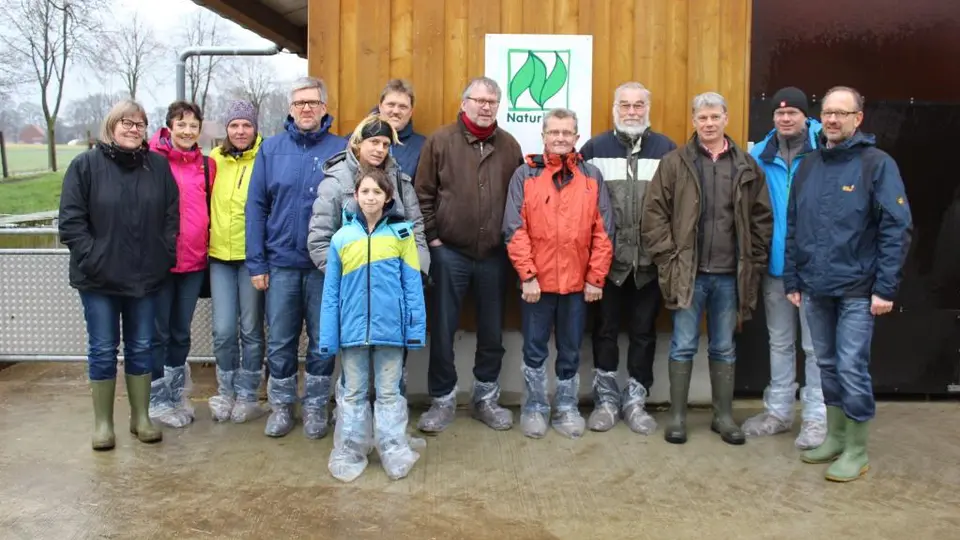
[593,274,663,392]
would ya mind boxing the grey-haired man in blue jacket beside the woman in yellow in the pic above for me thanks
[246,77,346,439]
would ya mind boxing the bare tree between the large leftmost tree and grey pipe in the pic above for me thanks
[100,12,165,99]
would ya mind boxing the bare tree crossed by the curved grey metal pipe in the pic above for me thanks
[180,10,227,111]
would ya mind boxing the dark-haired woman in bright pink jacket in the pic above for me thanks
[150,101,217,428]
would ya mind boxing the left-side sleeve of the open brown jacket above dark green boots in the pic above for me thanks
[640,154,677,266]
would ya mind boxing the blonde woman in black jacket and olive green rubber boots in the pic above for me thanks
[59,100,180,450]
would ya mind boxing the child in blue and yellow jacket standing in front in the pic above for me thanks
[320,169,426,482]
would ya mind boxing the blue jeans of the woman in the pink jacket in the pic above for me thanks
[153,270,204,381]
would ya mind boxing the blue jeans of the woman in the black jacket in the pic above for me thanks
[80,291,155,381]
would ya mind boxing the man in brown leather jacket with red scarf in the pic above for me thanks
[414,77,523,433]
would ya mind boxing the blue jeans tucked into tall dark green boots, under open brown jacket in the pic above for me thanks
[670,273,737,363]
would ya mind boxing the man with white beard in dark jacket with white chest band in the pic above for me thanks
[580,82,677,435]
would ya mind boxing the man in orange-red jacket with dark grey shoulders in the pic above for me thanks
[503,109,615,439]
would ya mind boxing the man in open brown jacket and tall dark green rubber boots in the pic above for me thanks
[640,92,773,444]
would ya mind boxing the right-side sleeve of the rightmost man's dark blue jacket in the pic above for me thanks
[873,154,913,301]
